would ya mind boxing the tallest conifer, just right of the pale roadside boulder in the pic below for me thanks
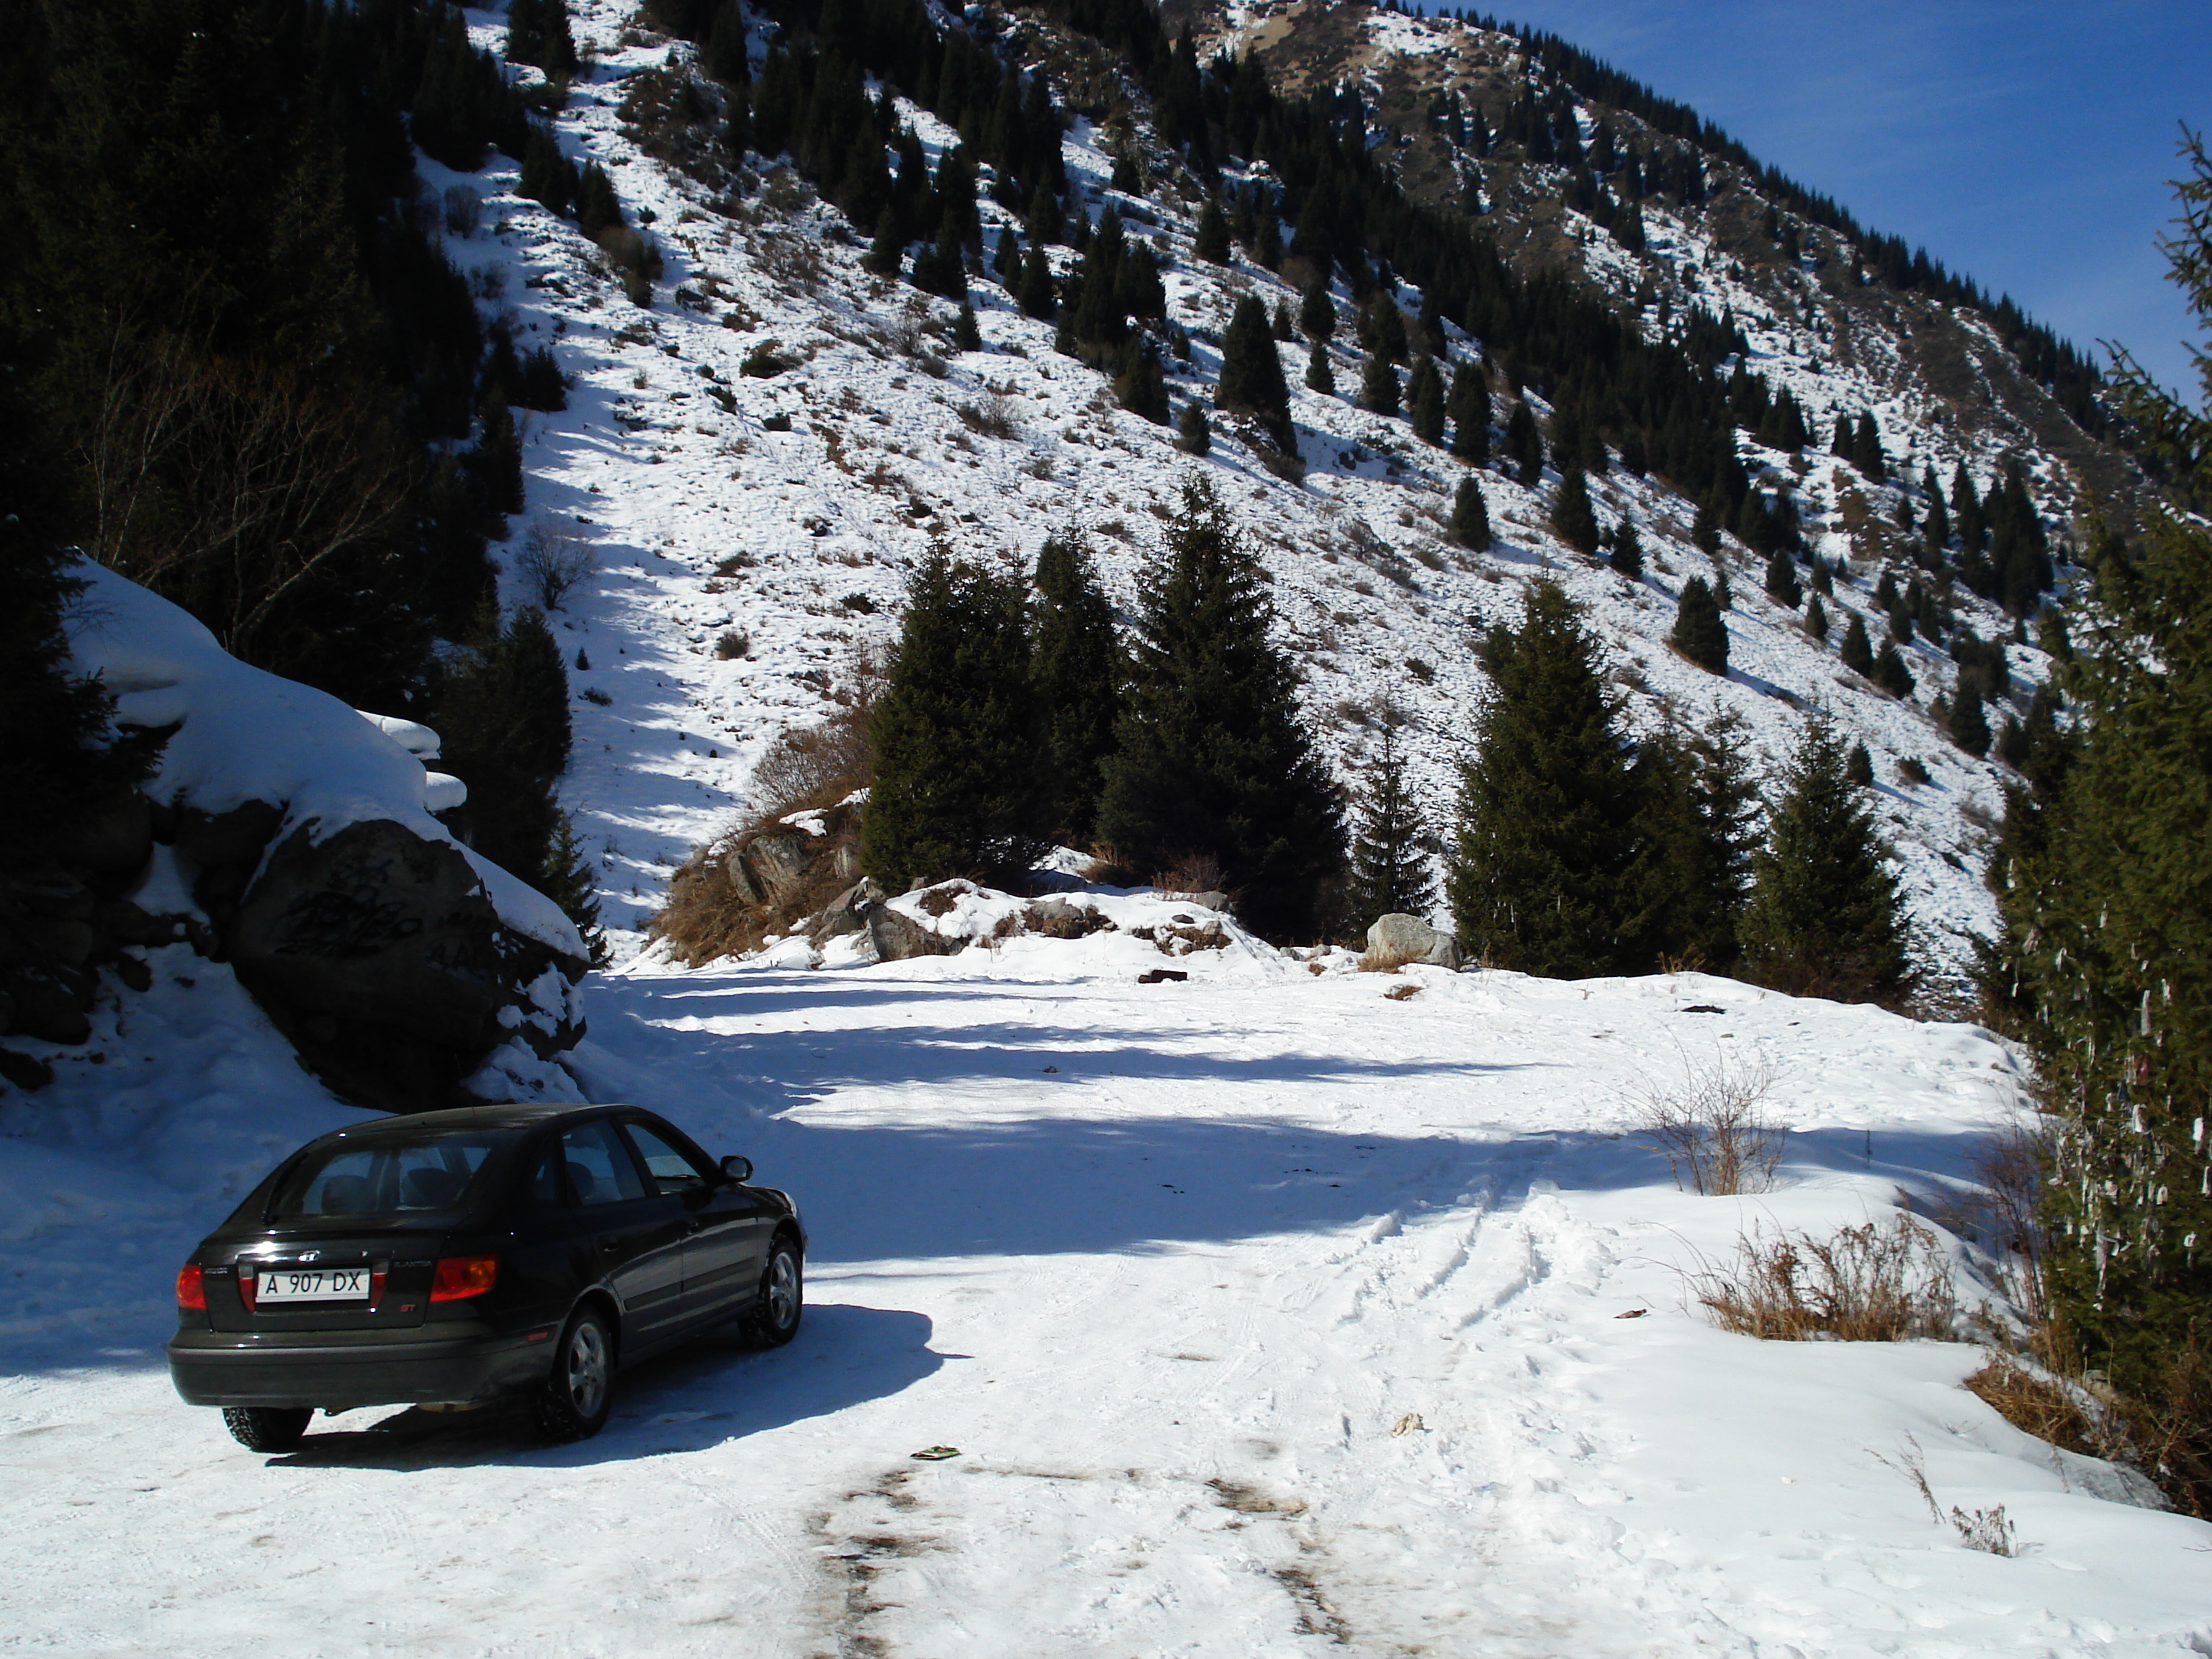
[1447,580,1643,978]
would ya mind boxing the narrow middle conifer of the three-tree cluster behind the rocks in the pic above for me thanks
[1031,535,1115,845]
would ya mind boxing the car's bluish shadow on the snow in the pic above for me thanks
[268,1303,947,1471]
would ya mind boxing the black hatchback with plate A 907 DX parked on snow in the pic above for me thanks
[168,1106,807,1451]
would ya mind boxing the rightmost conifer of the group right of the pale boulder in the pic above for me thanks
[1739,721,1913,1007]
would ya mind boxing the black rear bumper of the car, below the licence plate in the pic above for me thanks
[168,1331,555,1411]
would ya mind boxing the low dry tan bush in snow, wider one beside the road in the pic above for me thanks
[1690,1215,1958,1343]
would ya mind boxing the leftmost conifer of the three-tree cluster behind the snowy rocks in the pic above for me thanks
[860,547,1044,894]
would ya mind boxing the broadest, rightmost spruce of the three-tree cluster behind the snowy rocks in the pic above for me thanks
[1100,486,1345,938]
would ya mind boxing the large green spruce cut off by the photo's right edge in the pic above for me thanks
[1982,135,2212,1451]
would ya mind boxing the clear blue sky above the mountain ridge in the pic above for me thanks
[1471,0,2212,400]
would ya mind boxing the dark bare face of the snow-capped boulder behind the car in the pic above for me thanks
[228,821,588,1110]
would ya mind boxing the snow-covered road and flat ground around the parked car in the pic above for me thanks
[0,956,2212,1659]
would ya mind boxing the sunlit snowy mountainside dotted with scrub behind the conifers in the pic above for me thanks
[431,4,2064,971]
